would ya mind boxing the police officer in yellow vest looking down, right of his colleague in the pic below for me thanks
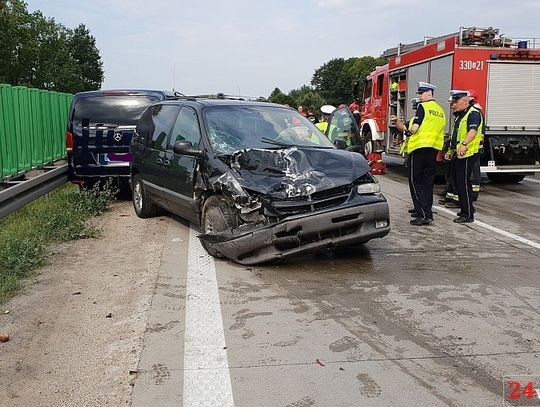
[445,90,483,223]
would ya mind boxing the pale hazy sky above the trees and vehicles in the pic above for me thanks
[26,0,540,97]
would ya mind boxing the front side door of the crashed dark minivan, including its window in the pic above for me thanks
[164,106,201,222]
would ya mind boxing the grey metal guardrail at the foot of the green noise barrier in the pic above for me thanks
[0,164,68,219]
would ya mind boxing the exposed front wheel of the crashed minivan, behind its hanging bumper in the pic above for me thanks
[201,195,238,259]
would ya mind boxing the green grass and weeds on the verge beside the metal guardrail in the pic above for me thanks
[0,183,118,303]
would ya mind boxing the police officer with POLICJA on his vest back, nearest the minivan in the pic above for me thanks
[405,82,446,226]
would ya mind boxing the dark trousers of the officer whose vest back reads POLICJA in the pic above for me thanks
[409,147,438,219]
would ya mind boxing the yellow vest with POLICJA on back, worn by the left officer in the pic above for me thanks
[407,100,446,154]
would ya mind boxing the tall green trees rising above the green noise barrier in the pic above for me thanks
[0,0,104,93]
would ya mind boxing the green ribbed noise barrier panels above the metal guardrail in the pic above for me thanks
[0,84,73,181]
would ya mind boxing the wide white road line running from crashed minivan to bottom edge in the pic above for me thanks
[183,229,234,407]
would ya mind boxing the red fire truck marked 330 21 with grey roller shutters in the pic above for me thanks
[360,27,540,182]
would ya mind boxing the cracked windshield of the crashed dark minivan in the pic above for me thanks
[204,105,334,154]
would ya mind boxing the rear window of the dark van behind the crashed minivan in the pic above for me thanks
[73,95,159,126]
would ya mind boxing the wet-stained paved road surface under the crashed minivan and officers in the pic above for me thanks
[133,161,540,407]
